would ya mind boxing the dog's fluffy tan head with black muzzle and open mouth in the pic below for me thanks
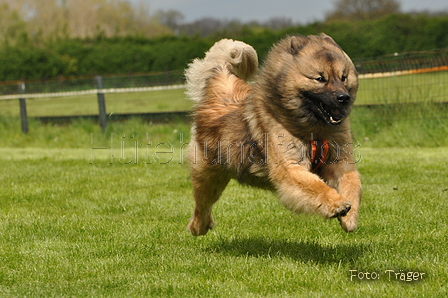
[265,34,358,125]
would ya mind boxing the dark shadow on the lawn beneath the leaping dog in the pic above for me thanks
[207,237,368,264]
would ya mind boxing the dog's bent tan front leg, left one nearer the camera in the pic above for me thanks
[271,164,351,218]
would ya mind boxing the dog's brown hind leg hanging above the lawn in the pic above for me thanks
[188,171,230,236]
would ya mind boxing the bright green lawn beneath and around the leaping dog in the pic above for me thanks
[0,117,448,297]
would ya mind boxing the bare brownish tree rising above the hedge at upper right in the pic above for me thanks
[327,0,400,21]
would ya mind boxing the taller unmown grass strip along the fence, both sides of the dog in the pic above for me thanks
[0,99,448,148]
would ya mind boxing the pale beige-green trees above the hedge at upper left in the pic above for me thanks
[0,0,172,43]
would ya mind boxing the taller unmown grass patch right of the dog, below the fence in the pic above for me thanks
[350,103,448,148]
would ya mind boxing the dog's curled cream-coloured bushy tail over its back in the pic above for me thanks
[185,39,258,102]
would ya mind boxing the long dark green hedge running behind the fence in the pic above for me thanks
[0,14,448,80]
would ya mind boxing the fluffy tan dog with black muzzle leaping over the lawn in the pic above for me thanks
[185,33,362,236]
